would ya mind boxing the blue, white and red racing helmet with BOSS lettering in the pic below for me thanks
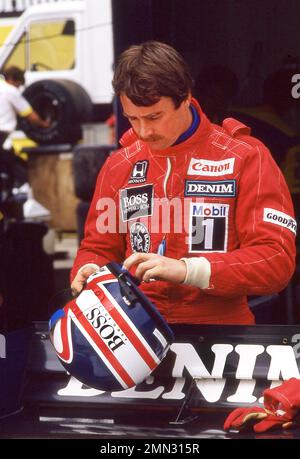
[49,263,174,391]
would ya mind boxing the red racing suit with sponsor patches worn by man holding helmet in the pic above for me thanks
[71,41,296,324]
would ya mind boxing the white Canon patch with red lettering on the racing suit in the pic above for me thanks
[187,158,235,177]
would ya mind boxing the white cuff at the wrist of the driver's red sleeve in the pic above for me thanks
[181,257,211,288]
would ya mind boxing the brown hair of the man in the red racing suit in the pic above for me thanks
[113,41,193,108]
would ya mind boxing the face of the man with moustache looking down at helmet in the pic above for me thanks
[120,93,192,150]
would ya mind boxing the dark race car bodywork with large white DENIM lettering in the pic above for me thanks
[0,322,300,438]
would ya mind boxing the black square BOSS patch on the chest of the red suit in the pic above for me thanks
[120,185,153,222]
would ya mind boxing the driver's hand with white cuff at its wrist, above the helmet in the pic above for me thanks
[123,253,186,284]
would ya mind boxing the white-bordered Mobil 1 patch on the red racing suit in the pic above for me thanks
[189,202,229,253]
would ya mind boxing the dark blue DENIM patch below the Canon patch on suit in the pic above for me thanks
[184,180,236,198]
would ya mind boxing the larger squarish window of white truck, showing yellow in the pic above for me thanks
[28,20,75,72]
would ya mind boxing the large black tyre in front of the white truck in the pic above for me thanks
[20,80,93,144]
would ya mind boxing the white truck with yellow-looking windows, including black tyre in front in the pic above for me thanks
[0,0,114,144]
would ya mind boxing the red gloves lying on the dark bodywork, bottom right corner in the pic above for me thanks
[224,378,300,432]
